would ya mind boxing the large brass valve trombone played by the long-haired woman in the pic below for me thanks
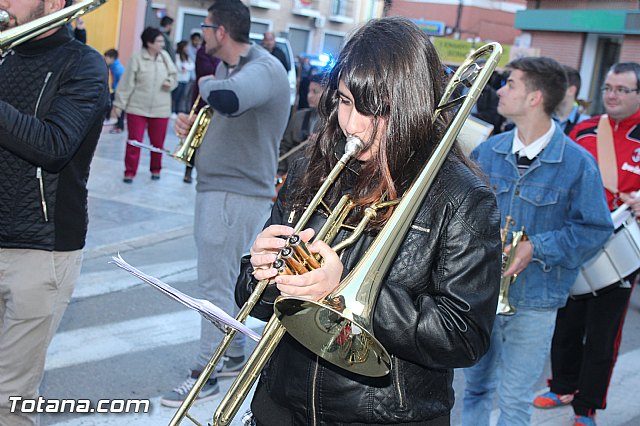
[170,43,502,426]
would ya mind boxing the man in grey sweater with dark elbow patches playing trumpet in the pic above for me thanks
[160,0,289,407]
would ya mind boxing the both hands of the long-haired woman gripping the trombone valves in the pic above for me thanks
[250,225,343,300]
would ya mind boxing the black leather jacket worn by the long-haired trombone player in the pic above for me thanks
[236,156,501,425]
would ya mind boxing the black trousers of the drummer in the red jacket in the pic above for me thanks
[549,280,635,416]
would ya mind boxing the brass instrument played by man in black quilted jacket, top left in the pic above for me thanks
[0,0,107,57]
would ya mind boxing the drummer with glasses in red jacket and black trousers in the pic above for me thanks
[533,62,640,426]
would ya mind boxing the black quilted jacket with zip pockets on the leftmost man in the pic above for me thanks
[0,26,109,251]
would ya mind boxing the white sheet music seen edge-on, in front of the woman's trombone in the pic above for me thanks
[110,254,260,342]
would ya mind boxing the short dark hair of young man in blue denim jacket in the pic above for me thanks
[507,56,567,116]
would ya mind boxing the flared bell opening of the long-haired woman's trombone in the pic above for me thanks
[275,297,391,377]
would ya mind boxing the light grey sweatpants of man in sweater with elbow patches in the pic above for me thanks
[193,191,271,371]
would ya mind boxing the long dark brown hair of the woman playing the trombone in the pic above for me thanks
[290,17,462,228]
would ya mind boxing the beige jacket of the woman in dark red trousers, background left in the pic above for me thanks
[113,48,178,118]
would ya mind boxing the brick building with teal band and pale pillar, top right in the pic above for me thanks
[515,0,640,113]
